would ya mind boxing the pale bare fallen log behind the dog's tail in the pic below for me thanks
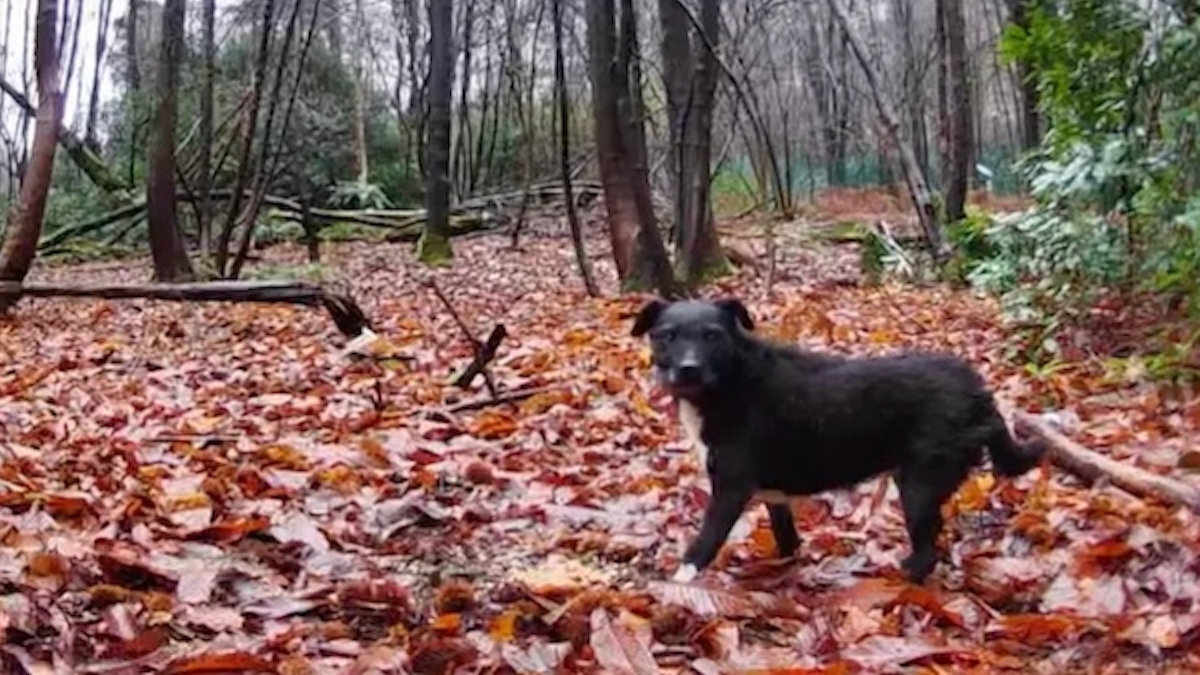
[1013,411,1200,513]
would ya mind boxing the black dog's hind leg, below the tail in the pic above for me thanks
[896,455,970,584]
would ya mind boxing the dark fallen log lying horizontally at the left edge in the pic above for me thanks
[0,281,371,338]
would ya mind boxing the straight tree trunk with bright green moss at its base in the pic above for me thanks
[416,2,454,264]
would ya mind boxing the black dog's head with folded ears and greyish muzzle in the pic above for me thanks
[632,298,754,399]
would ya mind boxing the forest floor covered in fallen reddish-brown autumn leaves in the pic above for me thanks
[0,186,1200,675]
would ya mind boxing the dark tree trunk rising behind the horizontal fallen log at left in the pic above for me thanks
[146,0,193,282]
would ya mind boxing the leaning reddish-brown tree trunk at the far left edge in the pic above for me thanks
[0,0,62,313]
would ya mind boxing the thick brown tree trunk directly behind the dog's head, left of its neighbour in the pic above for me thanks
[587,0,673,294]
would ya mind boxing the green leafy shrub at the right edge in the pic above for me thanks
[969,0,1200,357]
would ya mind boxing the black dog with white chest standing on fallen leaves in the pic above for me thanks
[632,299,1044,584]
